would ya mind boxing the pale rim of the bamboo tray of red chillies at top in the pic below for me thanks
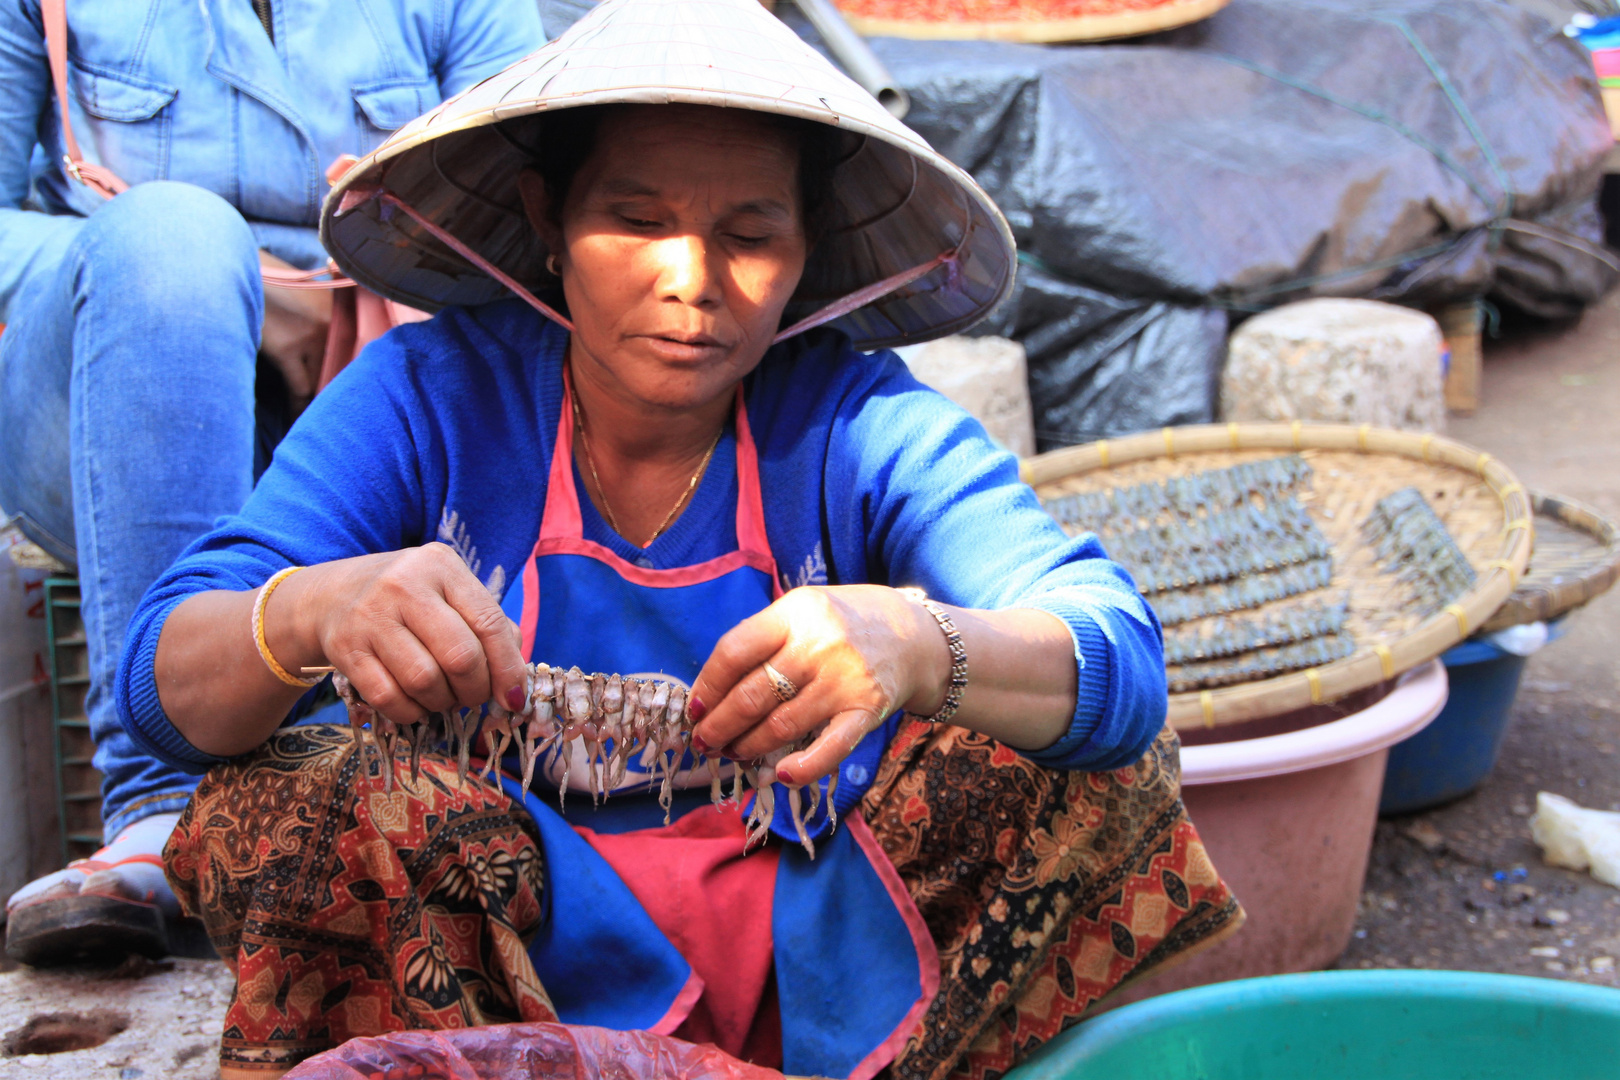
[834,0,1231,44]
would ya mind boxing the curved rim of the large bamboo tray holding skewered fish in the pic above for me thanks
[1019,421,1534,730]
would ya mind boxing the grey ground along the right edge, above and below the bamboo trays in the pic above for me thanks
[1341,291,1620,986]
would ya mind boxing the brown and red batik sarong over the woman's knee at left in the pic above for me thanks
[164,724,556,1070]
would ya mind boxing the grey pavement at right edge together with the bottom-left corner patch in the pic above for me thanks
[0,291,1620,1080]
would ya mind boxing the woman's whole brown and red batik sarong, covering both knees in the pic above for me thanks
[165,724,1243,1080]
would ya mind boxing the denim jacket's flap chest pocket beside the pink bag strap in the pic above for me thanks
[68,60,180,185]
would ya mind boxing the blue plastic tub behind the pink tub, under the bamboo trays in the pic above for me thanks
[1379,620,1561,816]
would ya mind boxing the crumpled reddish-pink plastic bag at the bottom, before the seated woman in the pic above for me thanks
[287,1023,782,1080]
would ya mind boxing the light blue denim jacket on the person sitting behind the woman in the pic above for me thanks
[0,0,544,322]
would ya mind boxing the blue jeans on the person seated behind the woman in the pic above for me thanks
[0,181,264,840]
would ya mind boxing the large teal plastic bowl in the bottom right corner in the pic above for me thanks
[1006,972,1620,1080]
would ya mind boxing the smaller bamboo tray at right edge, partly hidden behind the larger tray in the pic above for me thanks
[1481,492,1620,630]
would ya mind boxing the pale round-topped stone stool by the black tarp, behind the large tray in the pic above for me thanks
[1220,300,1445,431]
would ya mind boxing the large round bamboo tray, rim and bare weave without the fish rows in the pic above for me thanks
[1022,421,1534,729]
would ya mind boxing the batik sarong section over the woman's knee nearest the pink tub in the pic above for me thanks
[862,722,1243,1080]
